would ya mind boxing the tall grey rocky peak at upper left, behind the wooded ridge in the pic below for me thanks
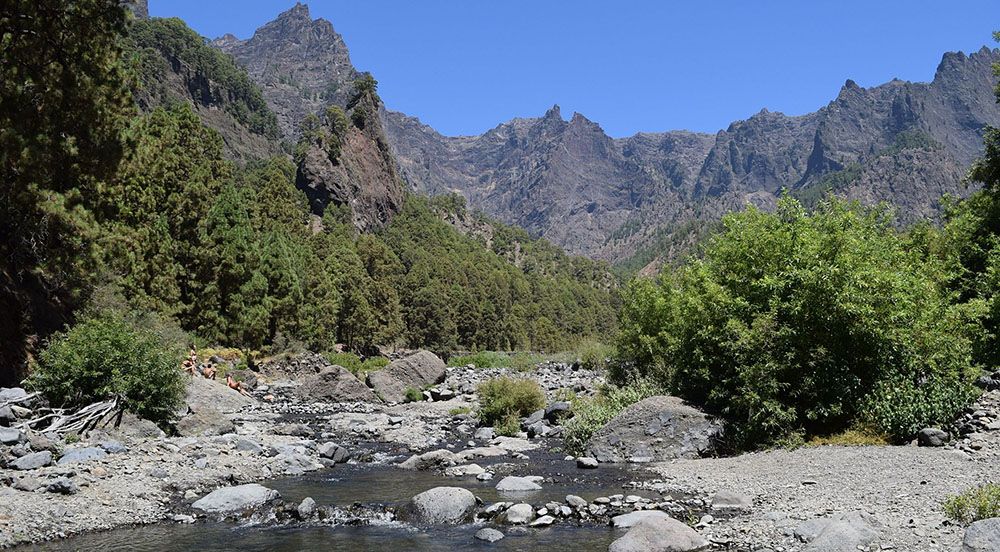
[212,3,360,141]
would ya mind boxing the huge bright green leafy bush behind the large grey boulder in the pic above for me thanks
[611,197,978,449]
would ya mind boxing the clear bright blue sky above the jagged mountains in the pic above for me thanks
[149,0,1000,137]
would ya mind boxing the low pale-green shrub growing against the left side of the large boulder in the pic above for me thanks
[563,380,661,454]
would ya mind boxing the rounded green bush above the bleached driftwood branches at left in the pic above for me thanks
[26,316,184,424]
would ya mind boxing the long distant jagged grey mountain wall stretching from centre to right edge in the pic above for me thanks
[384,48,1000,260]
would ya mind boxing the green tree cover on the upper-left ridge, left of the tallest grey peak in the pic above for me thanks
[129,18,281,139]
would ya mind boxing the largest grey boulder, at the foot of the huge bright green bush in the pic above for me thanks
[586,395,722,463]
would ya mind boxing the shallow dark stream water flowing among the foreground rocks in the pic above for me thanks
[19,452,658,552]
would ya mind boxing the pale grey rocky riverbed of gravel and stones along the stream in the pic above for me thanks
[0,355,1000,552]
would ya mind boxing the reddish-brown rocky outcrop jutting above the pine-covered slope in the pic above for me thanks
[296,92,404,231]
